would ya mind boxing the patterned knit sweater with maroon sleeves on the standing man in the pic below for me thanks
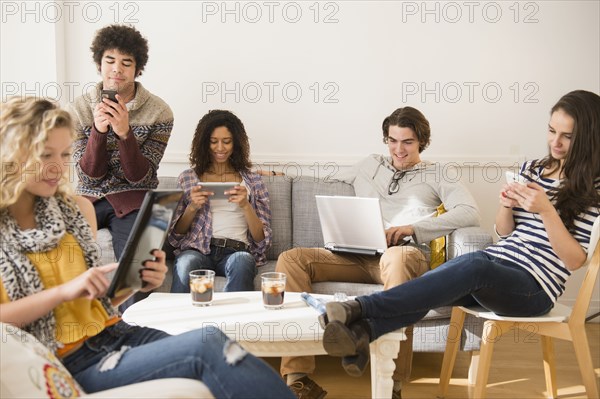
[69,82,173,217]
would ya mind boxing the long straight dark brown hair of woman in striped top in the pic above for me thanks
[531,90,600,232]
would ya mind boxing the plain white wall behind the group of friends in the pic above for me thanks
[0,0,600,318]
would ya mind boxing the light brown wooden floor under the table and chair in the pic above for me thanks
[265,323,600,399]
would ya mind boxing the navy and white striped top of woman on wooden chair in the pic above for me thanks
[485,161,600,302]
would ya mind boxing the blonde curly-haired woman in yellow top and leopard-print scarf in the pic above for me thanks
[0,98,294,398]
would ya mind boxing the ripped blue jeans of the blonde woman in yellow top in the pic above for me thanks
[62,321,294,398]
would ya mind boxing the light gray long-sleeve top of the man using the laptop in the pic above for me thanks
[340,154,479,244]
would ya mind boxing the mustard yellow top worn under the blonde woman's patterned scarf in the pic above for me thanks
[0,233,114,346]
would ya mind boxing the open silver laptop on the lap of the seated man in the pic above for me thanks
[315,195,387,255]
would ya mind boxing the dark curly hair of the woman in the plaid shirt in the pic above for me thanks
[190,110,252,177]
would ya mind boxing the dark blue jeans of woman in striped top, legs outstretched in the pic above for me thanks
[356,251,554,340]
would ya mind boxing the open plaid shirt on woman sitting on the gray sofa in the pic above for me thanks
[169,169,273,266]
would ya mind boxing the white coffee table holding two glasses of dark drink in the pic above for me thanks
[123,291,406,398]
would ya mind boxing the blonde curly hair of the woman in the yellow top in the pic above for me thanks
[0,96,74,209]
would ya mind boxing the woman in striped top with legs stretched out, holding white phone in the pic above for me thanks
[323,90,600,375]
